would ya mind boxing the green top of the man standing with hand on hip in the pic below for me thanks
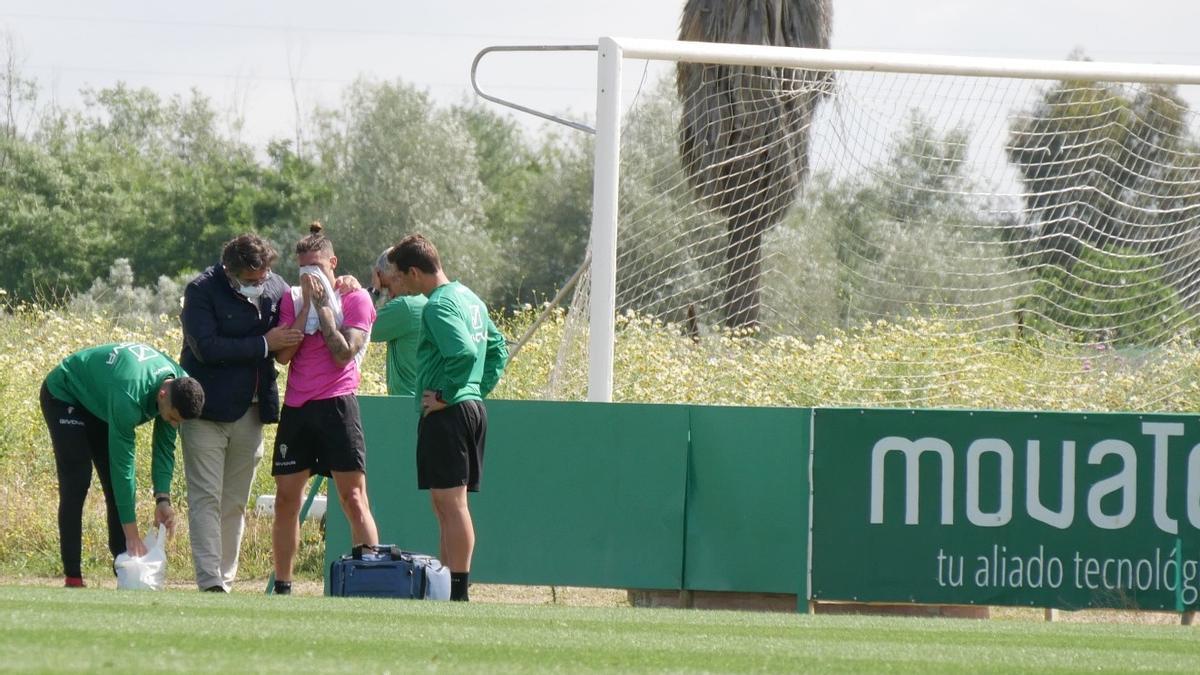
[416,281,509,411]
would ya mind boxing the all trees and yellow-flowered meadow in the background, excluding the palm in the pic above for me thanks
[7,45,1200,577]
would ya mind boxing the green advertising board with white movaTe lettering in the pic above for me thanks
[811,408,1200,610]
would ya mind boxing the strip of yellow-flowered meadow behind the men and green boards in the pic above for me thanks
[9,299,1200,579]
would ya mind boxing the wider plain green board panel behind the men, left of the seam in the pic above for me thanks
[325,396,688,589]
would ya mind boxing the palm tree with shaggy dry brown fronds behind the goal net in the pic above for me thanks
[676,0,833,328]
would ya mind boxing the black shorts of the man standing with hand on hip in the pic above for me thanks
[416,400,487,492]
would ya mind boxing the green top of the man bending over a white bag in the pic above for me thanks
[46,342,187,525]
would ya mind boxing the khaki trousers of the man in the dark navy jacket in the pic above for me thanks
[180,405,263,591]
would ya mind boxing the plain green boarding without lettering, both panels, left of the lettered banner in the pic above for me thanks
[325,396,811,598]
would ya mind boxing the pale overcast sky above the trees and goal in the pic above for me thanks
[0,0,1200,144]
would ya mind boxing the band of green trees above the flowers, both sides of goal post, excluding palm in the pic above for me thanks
[7,46,1200,345]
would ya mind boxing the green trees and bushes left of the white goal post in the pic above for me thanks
[0,57,592,306]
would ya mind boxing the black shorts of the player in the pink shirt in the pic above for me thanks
[271,394,367,476]
